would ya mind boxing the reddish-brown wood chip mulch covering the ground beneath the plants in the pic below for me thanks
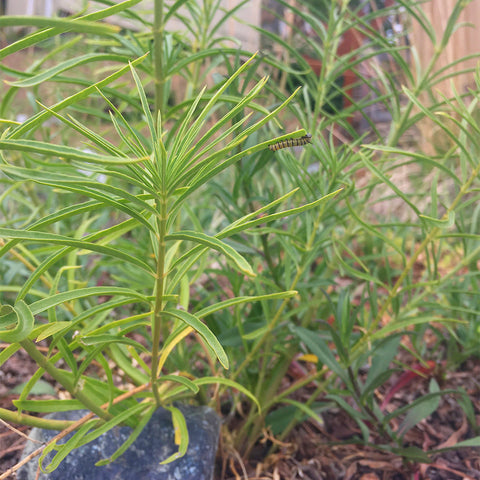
[0,344,480,480]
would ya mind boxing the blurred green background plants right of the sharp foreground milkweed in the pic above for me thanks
[203,1,479,461]
